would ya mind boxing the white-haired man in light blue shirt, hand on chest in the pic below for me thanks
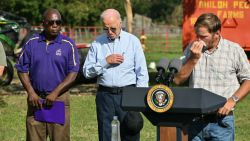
[83,9,149,141]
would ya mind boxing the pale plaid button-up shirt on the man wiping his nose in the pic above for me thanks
[183,38,250,98]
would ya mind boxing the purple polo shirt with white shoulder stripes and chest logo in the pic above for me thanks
[15,32,79,92]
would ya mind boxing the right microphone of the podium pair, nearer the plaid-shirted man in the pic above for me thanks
[167,59,182,85]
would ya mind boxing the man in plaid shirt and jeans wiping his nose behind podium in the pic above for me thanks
[173,13,250,141]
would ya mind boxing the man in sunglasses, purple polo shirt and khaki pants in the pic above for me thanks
[15,9,79,141]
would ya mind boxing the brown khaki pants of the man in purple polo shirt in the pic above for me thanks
[26,92,70,141]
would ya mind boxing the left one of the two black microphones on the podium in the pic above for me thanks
[155,58,169,83]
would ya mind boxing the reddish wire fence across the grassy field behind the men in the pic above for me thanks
[33,25,182,52]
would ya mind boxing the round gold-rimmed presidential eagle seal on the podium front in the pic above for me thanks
[147,84,174,113]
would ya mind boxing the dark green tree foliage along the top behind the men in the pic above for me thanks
[0,0,182,26]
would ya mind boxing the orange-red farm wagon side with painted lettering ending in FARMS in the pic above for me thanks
[183,0,250,51]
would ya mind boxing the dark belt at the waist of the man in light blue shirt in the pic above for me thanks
[98,84,135,94]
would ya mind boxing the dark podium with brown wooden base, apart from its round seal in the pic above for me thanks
[122,87,226,141]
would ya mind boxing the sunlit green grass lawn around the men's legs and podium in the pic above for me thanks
[0,95,250,141]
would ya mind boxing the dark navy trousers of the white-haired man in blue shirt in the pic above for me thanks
[96,90,140,141]
